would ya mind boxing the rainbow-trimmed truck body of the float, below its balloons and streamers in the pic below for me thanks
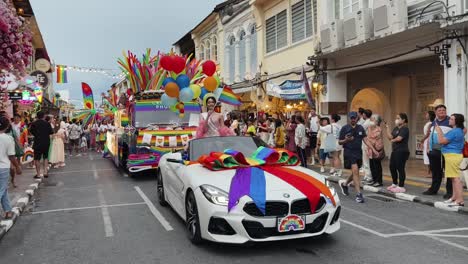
[107,92,200,177]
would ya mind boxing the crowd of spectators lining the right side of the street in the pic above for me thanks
[224,105,466,206]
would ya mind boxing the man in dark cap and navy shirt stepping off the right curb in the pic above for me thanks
[338,112,366,203]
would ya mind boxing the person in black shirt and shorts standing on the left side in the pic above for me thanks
[29,111,54,179]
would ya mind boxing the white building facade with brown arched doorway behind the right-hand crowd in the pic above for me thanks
[311,0,467,157]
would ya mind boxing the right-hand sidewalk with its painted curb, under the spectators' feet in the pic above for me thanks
[309,160,468,214]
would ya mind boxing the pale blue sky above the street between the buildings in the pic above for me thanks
[30,0,223,104]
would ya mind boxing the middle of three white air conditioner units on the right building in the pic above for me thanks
[343,8,374,47]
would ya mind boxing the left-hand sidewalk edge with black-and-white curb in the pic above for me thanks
[0,165,42,239]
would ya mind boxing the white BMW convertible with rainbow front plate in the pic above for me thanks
[157,137,341,244]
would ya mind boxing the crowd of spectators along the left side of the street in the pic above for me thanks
[0,111,115,219]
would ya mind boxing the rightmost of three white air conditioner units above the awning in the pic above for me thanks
[373,0,408,37]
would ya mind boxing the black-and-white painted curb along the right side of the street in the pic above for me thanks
[325,176,468,215]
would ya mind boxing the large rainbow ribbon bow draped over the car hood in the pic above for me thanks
[198,147,336,214]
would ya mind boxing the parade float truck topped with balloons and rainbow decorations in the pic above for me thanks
[105,49,240,176]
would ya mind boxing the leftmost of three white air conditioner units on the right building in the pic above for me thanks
[320,19,344,52]
